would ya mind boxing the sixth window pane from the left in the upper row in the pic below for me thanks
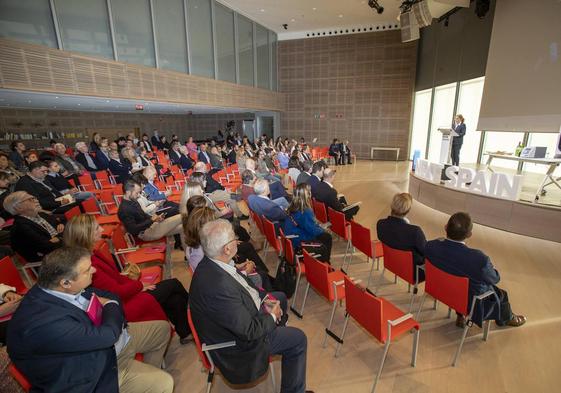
[214,3,236,83]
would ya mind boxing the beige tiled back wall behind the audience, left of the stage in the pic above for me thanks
[279,31,417,159]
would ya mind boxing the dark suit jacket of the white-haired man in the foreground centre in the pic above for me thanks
[189,257,276,384]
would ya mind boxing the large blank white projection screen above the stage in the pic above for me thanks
[477,0,561,132]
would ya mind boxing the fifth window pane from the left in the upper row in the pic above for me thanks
[187,0,214,78]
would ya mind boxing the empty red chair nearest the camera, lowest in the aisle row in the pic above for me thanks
[335,277,420,393]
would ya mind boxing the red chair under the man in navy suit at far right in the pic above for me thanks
[414,257,495,367]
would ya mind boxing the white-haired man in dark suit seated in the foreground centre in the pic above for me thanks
[189,219,307,393]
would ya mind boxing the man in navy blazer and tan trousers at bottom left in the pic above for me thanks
[7,248,173,393]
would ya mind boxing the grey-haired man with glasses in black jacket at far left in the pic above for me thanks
[4,191,64,262]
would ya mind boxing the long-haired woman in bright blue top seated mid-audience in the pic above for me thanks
[282,184,333,263]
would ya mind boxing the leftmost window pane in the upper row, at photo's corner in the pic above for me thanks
[0,0,58,48]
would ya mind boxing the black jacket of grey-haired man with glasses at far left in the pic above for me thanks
[10,213,62,262]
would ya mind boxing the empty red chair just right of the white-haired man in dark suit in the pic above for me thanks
[299,250,346,347]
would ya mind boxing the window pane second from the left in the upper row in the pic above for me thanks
[55,0,113,59]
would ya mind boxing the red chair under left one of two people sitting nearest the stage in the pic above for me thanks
[374,243,423,311]
